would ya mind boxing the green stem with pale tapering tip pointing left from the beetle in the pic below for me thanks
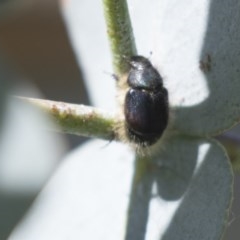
[18,97,115,140]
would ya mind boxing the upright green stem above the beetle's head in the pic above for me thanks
[103,0,136,76]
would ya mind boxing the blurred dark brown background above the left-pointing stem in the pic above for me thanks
[0,0,89,148]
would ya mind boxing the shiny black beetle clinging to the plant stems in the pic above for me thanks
[124,56,168,146]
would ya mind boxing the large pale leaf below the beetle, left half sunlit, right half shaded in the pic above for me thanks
[10,137,232,240]
